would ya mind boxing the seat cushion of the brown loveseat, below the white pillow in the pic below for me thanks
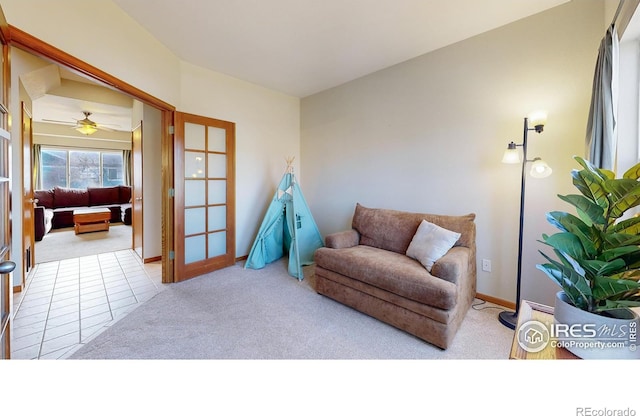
[315,245,457,310]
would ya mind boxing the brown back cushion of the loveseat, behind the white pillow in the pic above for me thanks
[352,204,476,254]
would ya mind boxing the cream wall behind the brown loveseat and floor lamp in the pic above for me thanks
[301,1,604,304]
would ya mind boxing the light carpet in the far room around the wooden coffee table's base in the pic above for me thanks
[35,224,132,263]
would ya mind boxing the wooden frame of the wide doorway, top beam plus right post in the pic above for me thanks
[8,25,175,283]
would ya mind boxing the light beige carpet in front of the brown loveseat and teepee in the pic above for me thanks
[70,261,513,360]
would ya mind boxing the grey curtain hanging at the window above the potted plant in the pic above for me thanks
[586,23,619,170]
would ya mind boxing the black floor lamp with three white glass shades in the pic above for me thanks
[498,113,551,329]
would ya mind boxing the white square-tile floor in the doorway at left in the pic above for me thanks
[11,250,164,360]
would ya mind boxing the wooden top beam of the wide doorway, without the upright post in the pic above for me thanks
[9,25,175,111]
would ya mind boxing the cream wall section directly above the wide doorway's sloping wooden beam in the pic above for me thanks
[0,0,180,109]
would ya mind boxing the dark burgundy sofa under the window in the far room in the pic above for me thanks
[33,185,131,241]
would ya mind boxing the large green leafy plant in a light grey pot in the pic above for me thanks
[537,157,640,358]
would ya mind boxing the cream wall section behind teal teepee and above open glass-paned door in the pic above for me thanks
[180,62,304,257]
